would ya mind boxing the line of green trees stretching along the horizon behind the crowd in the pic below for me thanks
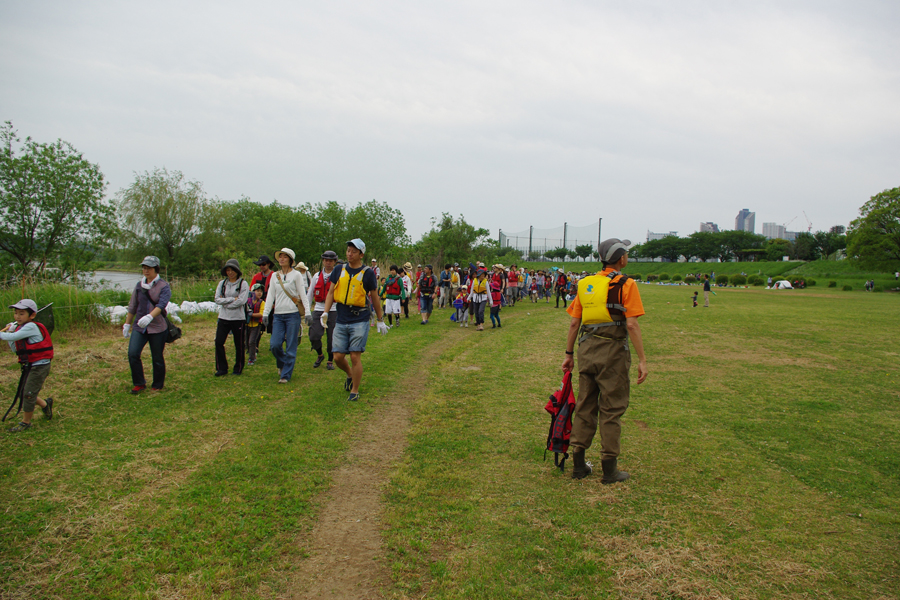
[0,121,900,279]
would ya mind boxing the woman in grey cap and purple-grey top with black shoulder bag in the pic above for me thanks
[122,256,172,394]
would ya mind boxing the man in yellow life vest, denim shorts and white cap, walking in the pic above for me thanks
[321,238,388,402]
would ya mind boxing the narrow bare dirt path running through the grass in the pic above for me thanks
[281,341,446,600]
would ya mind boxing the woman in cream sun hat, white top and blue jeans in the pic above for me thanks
[263,248,309,383]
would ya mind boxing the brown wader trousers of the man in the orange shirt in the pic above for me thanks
[571,327,631,459]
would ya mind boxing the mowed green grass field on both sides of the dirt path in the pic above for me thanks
[0,285,900,599]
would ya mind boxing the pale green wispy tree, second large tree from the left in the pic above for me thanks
[116,168,209,272]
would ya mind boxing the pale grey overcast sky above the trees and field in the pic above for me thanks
[0,0,900,242]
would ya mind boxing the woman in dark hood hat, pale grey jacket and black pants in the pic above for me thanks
[215,258,250,377]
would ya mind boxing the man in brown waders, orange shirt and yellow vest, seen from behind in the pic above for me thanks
[562,238,647,483]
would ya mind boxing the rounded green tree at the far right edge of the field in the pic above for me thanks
[847,187,900,268]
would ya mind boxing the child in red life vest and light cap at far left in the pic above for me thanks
[0,298,53,433]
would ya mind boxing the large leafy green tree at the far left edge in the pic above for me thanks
[0,121,115,275]
